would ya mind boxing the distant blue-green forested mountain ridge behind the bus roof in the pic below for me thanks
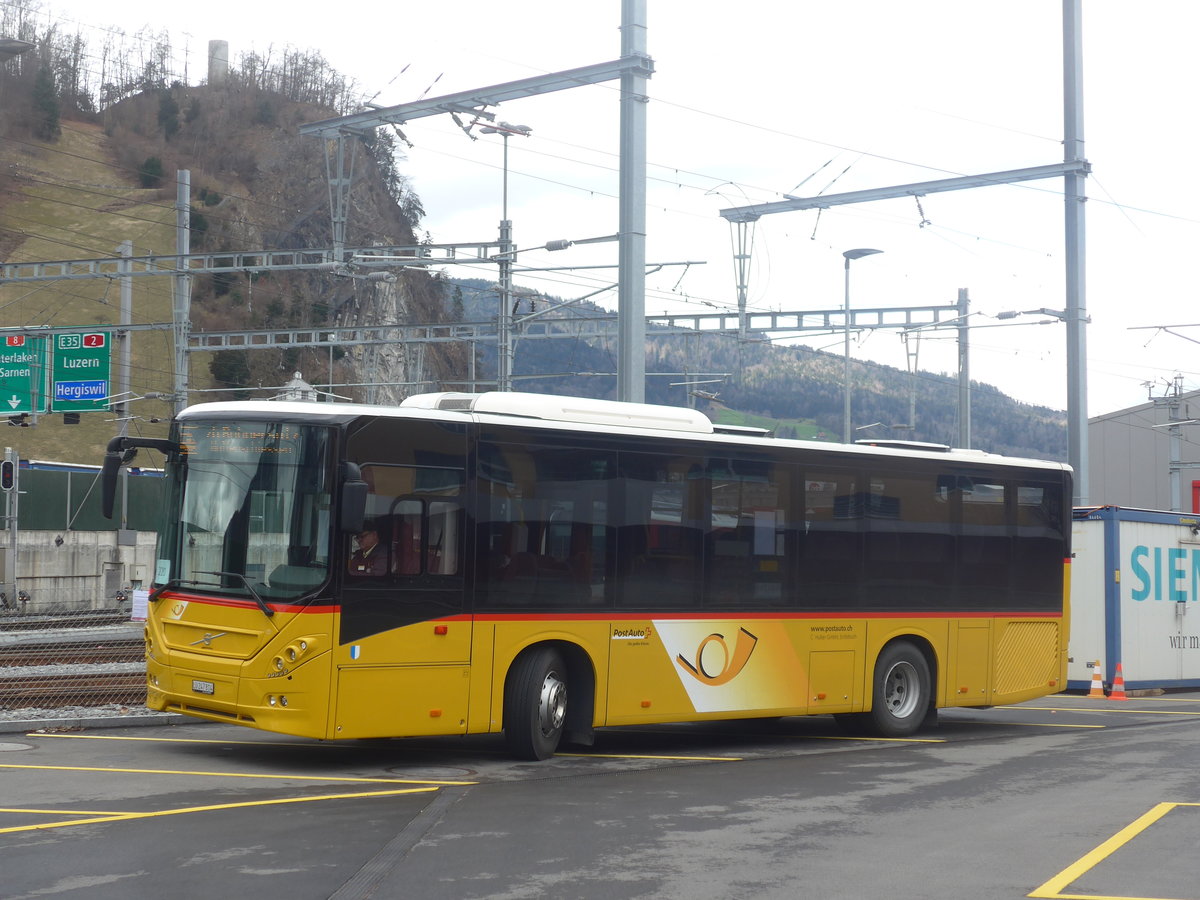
[450,278,1067,460]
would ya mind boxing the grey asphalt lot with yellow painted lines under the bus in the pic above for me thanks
[0,694,1200,900]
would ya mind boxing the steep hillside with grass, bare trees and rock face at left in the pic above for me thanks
[0,36,466,463]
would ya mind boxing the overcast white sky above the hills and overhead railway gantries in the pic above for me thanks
[16,0,1200,415]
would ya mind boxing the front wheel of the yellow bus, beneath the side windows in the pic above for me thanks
[504,647,566,760]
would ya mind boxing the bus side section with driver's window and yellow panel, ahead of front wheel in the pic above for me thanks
[329,432,472,738]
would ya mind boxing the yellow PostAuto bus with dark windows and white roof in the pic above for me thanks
[104,392,1070,758]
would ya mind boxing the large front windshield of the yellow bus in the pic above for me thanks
[155,420,332,604]
